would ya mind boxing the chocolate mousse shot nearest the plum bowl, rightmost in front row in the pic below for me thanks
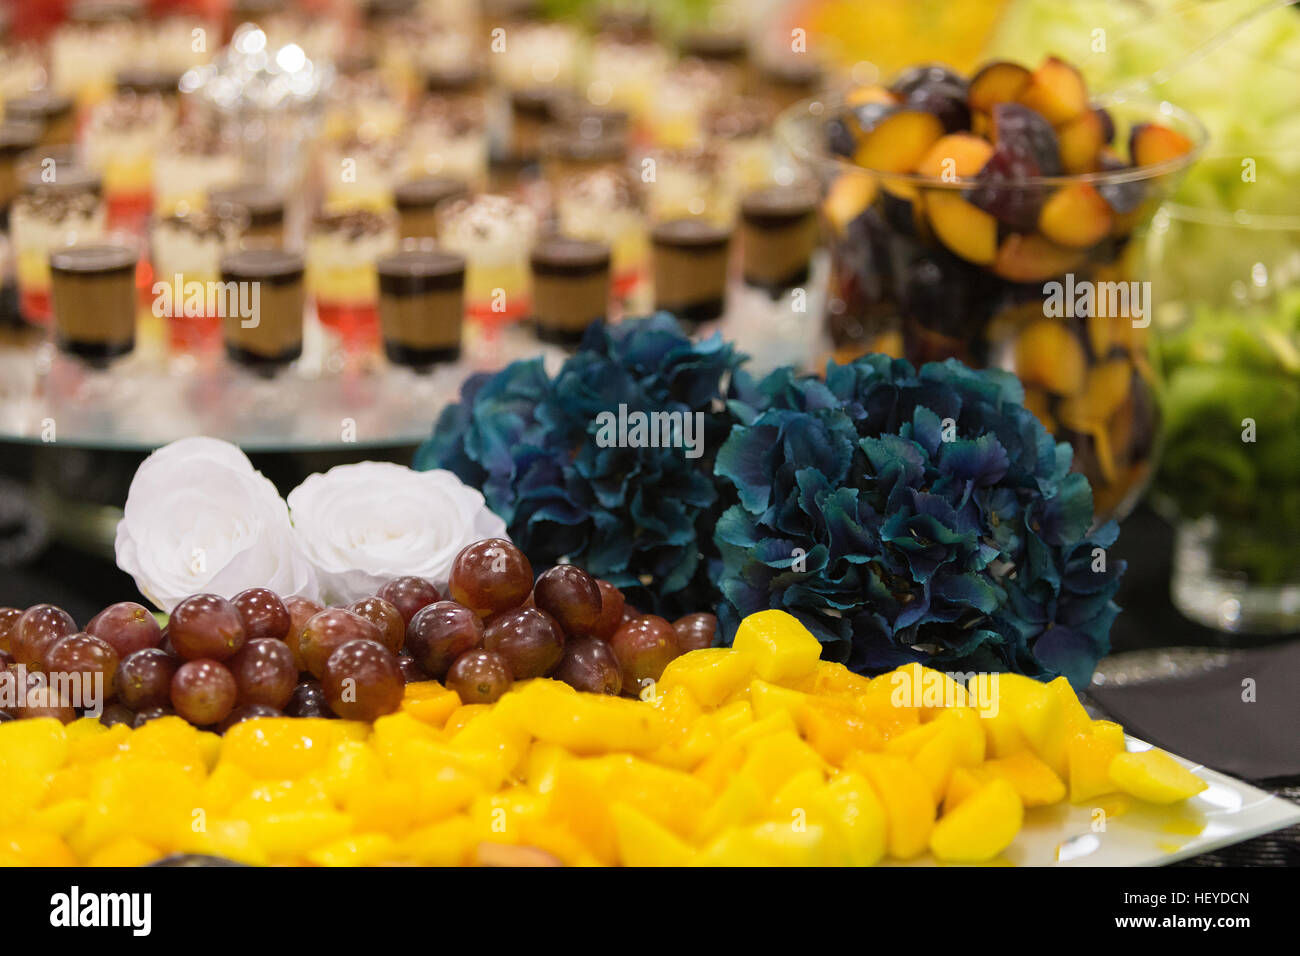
[740,186,818,299]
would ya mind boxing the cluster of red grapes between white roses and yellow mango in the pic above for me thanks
[0,538,718,731]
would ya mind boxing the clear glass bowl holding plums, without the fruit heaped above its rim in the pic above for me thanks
[779,95,1205,520]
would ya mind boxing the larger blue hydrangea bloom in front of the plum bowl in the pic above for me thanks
[714,355,1123,688]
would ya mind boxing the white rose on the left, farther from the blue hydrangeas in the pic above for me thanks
[116,438,319,611]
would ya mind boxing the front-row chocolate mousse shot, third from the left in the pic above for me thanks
[376,250,465,369]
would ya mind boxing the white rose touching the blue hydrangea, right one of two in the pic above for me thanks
[289,462,506,604]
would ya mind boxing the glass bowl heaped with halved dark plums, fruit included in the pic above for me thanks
[779,57,1205,520]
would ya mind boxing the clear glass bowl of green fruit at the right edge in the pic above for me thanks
[1147,152,1300,633]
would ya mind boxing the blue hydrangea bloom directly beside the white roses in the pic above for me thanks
[415,313,757,617]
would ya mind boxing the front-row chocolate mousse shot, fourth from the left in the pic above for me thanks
[530,235,610,346]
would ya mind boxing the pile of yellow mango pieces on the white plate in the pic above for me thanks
[0,611,1205,866]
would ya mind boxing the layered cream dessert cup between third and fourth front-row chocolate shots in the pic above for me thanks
[438,194,538,326]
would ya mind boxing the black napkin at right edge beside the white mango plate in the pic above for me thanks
[1088,641,1300,780]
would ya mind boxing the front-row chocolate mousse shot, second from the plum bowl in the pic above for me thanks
[650,219,731,326]
